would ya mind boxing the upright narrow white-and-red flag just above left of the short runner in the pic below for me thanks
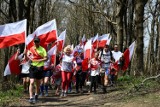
[84,39,92,59]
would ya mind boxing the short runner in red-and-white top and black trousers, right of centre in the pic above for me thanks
[89,52,101,94]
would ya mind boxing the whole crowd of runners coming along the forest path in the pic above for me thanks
[15,37,123,103]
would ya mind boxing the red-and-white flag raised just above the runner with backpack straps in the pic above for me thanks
[98,34,109,48]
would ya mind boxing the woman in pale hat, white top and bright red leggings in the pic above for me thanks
[60,45,76,97]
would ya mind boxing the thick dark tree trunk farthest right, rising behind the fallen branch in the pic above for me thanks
[135,0,147,74]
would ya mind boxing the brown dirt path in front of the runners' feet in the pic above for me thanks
[10,88,160,107]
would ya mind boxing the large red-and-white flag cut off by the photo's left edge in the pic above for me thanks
[0,19,27,48]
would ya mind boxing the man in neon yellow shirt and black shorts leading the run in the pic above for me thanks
[28,37,47,103]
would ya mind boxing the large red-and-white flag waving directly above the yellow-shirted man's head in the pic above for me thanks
[26,19,57,49]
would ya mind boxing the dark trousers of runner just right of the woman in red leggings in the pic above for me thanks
[76,71,86,91]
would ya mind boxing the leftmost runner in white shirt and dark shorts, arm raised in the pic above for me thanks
[15,49,30,93]
